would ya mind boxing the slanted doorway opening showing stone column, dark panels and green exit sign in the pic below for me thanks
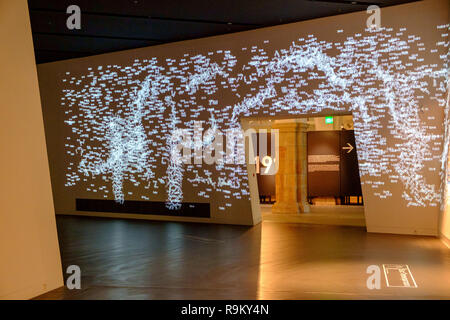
[249,115,365,227]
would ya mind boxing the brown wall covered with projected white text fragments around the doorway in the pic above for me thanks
[39,1,449,234]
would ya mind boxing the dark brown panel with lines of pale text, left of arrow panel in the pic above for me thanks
[307,131,340,197]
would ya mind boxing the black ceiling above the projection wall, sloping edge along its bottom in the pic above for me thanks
[28,0,411,63]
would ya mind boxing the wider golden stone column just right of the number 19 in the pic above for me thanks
[272,122,299,213]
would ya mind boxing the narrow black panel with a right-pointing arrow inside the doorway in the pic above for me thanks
[340,130,362,196]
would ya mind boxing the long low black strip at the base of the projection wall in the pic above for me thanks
[75,199,211,218]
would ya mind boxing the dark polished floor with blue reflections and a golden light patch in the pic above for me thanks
[38,216,450,299]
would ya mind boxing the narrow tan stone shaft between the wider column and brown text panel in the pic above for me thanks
[297,122,310,212]
